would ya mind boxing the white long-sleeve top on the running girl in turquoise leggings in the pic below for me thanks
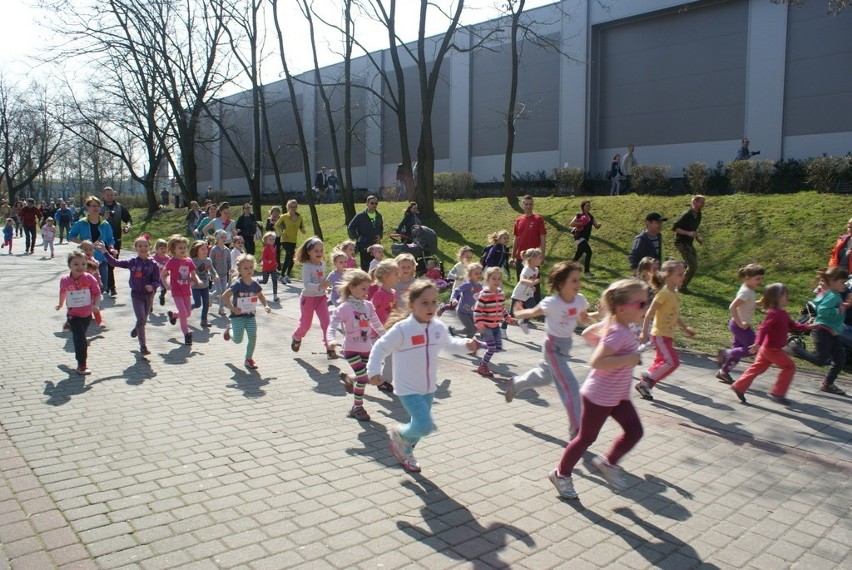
[367,315,468,396]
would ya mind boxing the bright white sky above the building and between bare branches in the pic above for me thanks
[0,0,553,91]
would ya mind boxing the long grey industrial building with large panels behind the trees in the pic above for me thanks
[198,0,852,195]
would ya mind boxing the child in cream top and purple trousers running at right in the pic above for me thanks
[716,263,766,384]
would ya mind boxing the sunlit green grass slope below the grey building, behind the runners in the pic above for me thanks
[132,192,852,354]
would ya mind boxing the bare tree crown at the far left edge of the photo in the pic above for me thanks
[0,76,62,202]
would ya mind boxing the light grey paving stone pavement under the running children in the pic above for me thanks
[0,240,852,570]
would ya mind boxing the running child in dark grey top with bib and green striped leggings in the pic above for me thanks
[222,253,271,370]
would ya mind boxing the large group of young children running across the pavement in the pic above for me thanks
[48,207,849,499]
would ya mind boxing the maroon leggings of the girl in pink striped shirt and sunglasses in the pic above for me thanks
[558,396,642,477]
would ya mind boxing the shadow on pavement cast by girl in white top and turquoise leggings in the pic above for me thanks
[396,473,535,568]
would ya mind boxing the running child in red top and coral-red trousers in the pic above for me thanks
[731,283,812,406]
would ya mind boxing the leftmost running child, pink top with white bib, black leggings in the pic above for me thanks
[56,249,101,376]
